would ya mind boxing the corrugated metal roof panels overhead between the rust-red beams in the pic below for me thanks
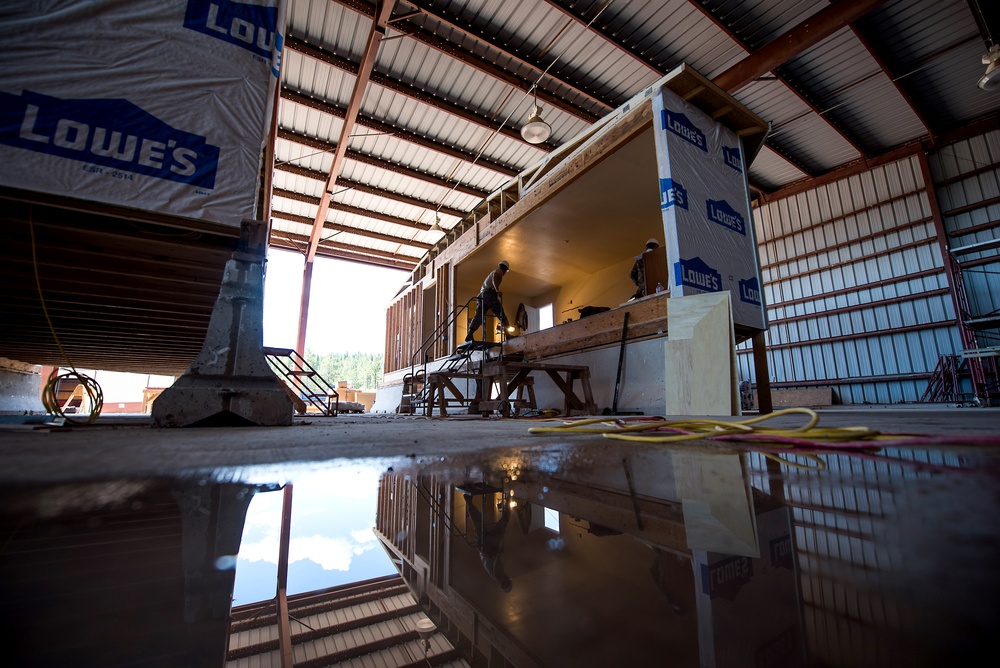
[274,0,1000,272]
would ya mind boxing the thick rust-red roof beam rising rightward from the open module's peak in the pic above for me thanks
[714,0,886,93]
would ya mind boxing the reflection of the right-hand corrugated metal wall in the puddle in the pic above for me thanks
[748,450,963,665]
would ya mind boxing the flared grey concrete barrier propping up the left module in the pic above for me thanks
[152,220,292,427]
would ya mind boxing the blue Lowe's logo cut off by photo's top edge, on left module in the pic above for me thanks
[184,0,282,74]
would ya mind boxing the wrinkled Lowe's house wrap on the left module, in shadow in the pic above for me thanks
[0,0,284,226]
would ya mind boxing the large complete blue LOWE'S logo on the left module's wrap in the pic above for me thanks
[0,90,219,190]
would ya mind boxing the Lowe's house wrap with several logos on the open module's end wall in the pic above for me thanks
[653,88,766,329]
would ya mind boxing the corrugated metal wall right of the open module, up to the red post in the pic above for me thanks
[739,153,964,403]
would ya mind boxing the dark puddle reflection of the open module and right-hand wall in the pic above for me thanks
[377,449,1000,667]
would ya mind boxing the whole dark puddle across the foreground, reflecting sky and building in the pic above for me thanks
[0,445,1000,666]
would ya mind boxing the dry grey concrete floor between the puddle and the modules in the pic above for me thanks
[0,406,1000,485]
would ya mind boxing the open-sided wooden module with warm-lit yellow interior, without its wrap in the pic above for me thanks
[386,66,770,411]
